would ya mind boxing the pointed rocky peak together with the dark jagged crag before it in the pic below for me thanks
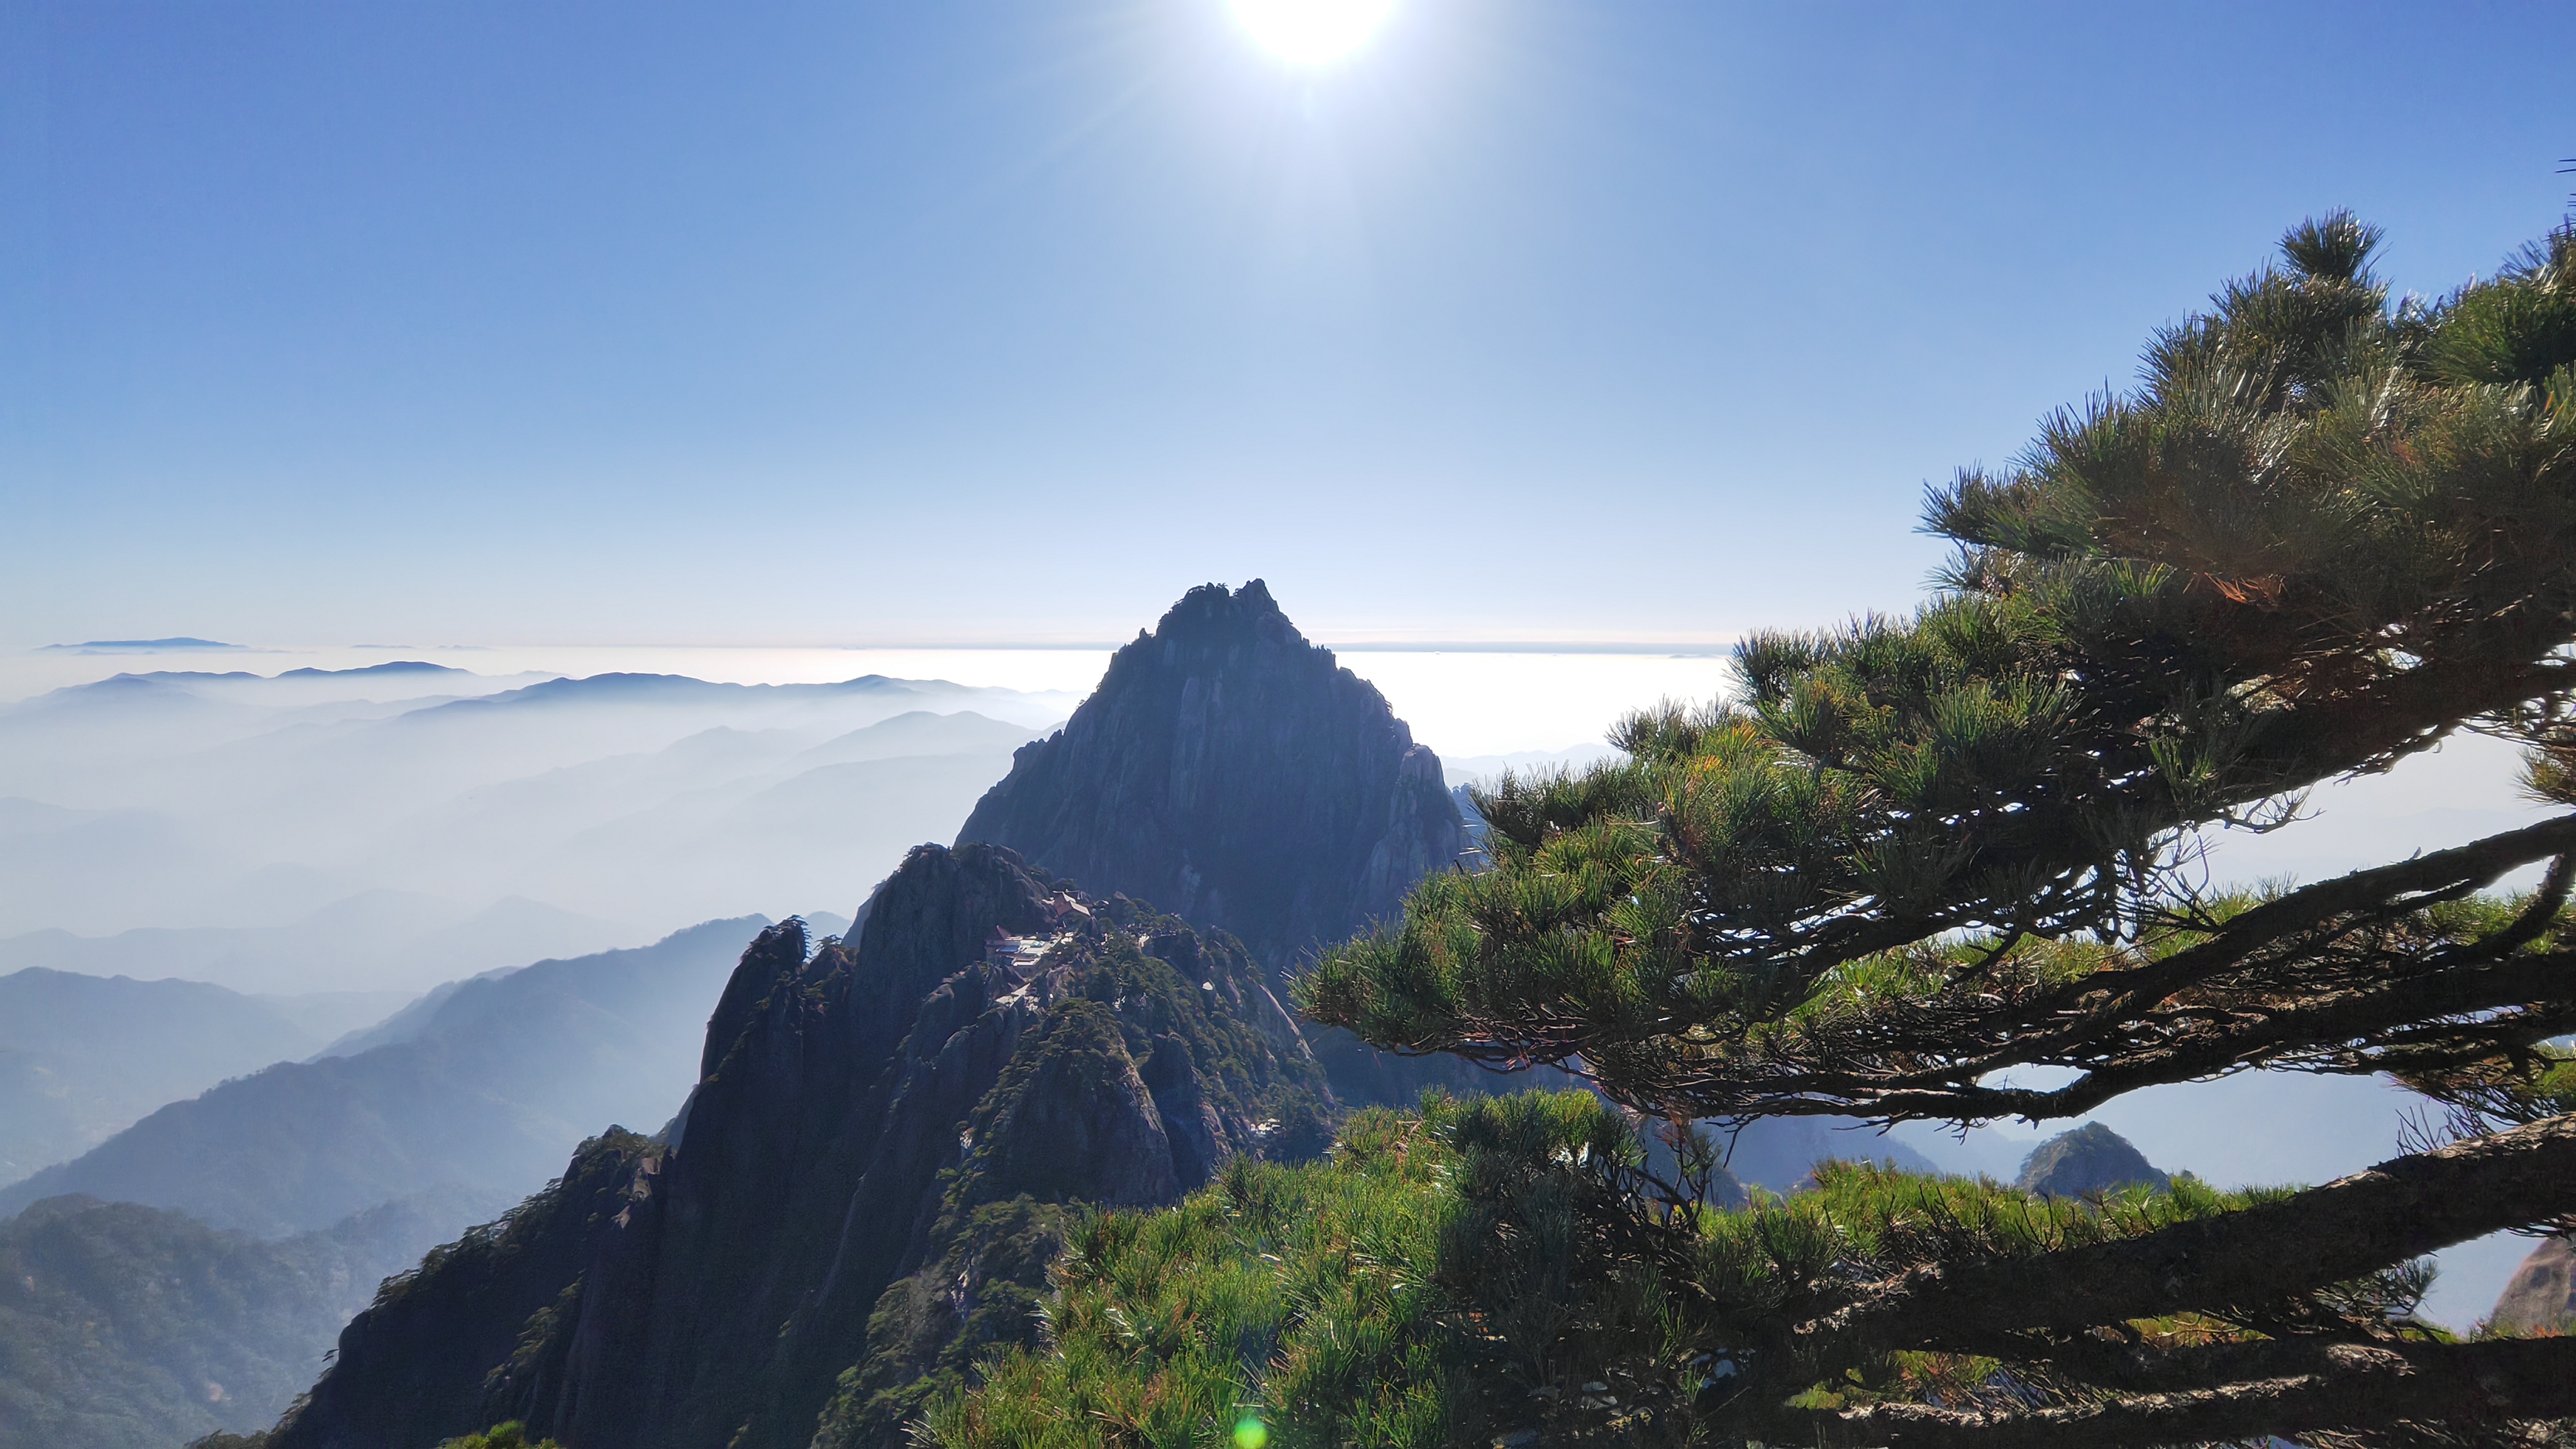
[248,580,1466,1449]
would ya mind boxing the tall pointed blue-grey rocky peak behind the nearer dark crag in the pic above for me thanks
[958,580,1474,1104]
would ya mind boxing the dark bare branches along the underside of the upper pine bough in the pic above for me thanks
[1579,814,2576,1121]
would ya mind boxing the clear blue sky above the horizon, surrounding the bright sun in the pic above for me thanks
[0,0,2576,647]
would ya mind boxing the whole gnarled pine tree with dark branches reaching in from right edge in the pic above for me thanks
[1301,214,2576,1449]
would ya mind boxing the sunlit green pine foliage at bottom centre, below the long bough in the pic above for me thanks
[924,1091,2359,1449]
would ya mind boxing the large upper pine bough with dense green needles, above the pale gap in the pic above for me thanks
[1301,214,2576,1121]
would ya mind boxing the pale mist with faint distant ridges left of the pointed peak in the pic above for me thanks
[0,660,1072,974]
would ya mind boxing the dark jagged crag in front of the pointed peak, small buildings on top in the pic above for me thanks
[273,846,1330,1449]
